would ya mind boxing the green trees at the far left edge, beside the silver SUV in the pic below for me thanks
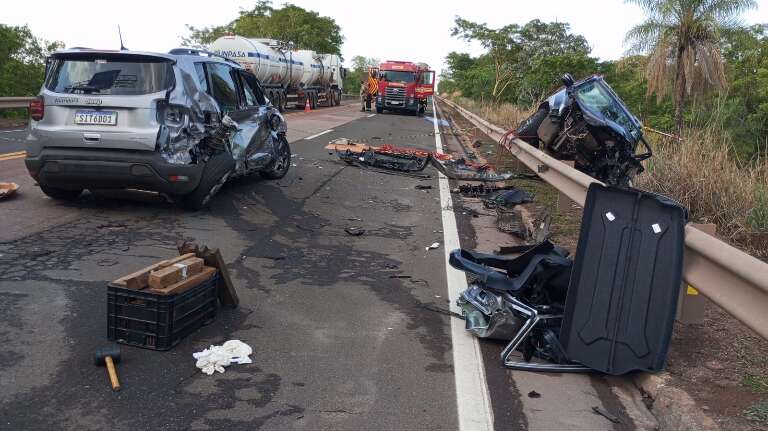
[0,24,64,96]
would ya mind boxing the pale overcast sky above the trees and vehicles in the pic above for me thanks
[0,0,768,81]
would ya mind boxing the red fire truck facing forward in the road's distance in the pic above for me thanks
[376,60,435,115]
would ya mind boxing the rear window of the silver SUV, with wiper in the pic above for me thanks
[45,56,173,96]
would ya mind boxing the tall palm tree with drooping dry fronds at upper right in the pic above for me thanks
[625,0,756,134]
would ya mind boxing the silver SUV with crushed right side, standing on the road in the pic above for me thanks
[26,49,291,209]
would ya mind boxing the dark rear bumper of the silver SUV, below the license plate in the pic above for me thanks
[25,148,203,195]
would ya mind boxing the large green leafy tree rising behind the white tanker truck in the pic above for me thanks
[182,0,344,54]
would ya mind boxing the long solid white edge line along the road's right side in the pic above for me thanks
[432,98,493,431]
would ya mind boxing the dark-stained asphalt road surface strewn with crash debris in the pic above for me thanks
[0,106,652,430]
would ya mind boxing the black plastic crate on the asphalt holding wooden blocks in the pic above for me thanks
[107,272,219,350]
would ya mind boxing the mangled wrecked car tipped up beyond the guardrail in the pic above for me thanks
[515,74,652,186]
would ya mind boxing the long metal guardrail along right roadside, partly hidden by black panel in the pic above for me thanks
[438,97,768,339]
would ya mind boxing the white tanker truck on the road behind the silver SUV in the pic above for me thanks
[209,35,346,111]
